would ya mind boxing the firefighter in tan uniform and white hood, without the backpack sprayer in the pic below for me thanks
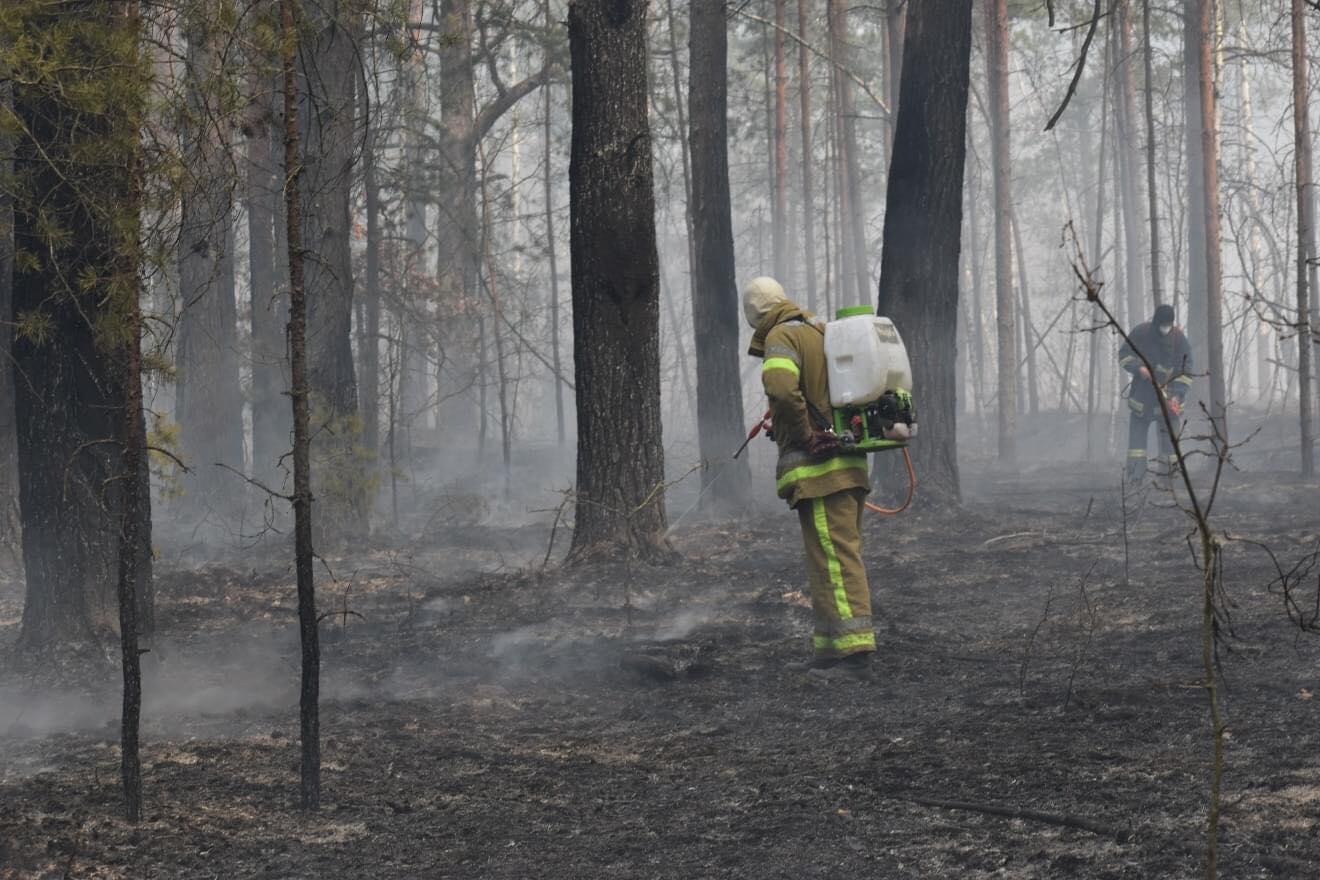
[743,277,875,679]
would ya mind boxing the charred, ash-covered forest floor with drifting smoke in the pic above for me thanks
[0,471,1320,879]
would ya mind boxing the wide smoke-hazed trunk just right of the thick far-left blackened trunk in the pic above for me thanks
[176,7,243,515]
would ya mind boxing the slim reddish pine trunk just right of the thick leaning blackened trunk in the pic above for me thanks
[985,0,1018,462]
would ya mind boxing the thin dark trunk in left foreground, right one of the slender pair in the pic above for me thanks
[280,0,321,810]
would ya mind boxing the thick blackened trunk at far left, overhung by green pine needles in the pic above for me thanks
[12,0,150,650]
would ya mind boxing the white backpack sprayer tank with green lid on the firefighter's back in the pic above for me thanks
[825,306,916,453]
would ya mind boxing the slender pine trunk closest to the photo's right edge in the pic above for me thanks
[1291,0,1316,476]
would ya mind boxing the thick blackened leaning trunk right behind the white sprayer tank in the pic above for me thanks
[879,0,972,504]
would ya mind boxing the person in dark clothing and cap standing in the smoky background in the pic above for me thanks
[1118,305,1192,483]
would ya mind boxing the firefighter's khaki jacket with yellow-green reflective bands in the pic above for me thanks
[747,302,871,507]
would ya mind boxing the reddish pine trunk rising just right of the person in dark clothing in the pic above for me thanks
[1196,0,1229,441]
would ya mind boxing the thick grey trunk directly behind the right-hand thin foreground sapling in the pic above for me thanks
[290,0,367,541]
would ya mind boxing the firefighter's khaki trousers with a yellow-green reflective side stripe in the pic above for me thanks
[796,489,875,657]
